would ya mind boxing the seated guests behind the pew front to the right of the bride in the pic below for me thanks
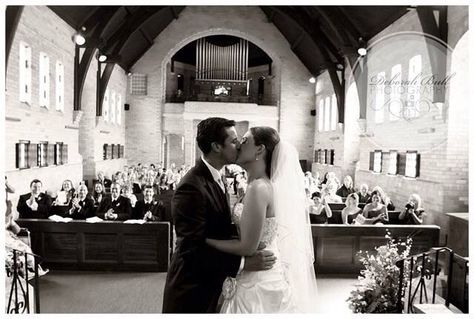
[305,172,426,225]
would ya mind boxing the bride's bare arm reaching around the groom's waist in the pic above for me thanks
[206,181,271,256]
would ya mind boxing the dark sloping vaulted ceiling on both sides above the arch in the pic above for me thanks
[49,6,407,75]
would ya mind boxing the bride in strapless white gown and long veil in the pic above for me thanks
[206,127,317,313]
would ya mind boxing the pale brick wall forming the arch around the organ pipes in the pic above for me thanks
[127,6,314,166]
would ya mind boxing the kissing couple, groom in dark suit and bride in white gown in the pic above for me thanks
[163,117,317,314]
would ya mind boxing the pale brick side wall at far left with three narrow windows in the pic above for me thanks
[3,6,82,205]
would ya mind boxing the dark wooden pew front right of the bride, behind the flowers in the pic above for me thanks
[311,224,440,274]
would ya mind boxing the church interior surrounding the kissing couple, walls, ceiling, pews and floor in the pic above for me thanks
[2,5,472,314]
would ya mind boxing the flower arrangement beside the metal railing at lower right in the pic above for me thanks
[346,231,412,313]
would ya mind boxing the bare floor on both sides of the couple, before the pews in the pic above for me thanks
[40,270,357,314]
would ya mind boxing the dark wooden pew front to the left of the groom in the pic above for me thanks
[18,219,170,272]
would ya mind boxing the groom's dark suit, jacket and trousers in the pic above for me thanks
[163,160,241,313]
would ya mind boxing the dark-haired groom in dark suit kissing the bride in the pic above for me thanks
[163,117,275,313]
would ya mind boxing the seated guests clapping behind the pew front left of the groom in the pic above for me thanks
[17,164,189,221]
